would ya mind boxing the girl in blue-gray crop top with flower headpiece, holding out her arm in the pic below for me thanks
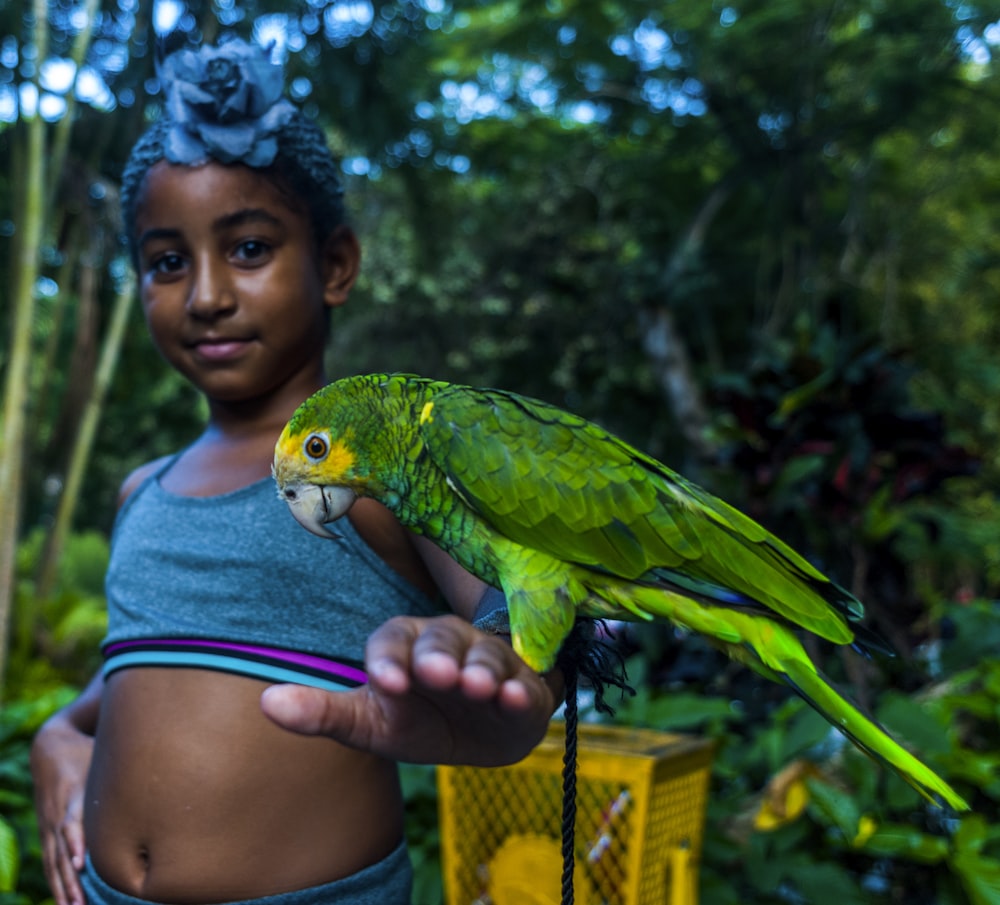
[32,35,558,905]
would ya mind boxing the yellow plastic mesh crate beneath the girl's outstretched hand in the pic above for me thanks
[438,723,712,905]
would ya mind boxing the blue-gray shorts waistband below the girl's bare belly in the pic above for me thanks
[80,843,413,905]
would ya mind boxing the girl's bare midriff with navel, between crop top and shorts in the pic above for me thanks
[85,668,402,903]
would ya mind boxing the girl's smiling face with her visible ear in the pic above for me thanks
[129,161,358,404]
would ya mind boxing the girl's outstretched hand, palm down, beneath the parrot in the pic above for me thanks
[261,616,560,767]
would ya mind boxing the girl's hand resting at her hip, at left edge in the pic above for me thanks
[31,713,94,905]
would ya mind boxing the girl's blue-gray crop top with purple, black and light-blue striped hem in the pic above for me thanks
[102,465,440,689]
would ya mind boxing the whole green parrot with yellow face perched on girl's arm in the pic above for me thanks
[274,374,968,810]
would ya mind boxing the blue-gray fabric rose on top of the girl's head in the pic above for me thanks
[158,39,295,167]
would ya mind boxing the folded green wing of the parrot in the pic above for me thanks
[420,386,863,644]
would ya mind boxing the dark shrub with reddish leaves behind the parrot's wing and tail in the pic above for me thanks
[714,327,984,652]
